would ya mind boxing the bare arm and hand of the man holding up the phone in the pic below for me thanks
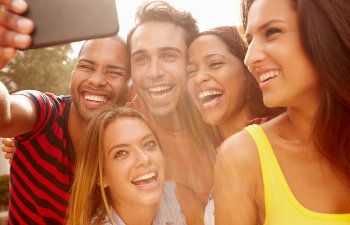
[0,0,36,137]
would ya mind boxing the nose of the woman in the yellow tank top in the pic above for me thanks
[244,40,266,72]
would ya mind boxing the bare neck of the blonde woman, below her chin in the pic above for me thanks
[113,203,158,225]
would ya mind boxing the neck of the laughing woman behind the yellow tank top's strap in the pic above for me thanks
[218,106,254,140]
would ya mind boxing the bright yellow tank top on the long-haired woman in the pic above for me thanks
[245,124,350,225]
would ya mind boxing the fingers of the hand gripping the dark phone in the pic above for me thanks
[0,0,34,69]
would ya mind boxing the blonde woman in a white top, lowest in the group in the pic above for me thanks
[67,106,186,225]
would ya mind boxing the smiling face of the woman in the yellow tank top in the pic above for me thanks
[245,0,321,107]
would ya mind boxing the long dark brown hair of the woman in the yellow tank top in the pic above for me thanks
[242,0,350,180]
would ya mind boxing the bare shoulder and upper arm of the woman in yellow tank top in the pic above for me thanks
[214,131,260,225]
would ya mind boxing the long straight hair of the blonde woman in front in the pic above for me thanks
[67,105,158,225]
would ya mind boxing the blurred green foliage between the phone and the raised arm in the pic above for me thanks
[0,44,75,95]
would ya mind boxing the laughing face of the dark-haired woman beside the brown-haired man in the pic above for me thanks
[187,35,247,125]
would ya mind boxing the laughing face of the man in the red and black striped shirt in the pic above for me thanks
[71,38,129,120]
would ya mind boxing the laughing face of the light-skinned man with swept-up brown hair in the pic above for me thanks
[130,21,187,117]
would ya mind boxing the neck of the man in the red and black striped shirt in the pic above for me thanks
[68,103,87,149]
